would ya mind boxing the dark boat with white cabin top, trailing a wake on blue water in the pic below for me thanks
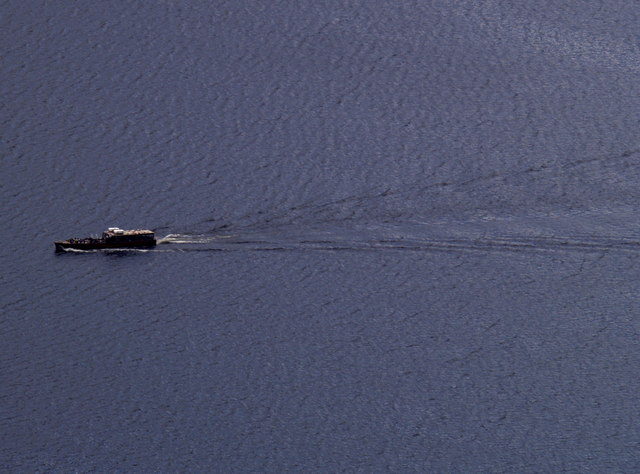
[54,227,156,252]
